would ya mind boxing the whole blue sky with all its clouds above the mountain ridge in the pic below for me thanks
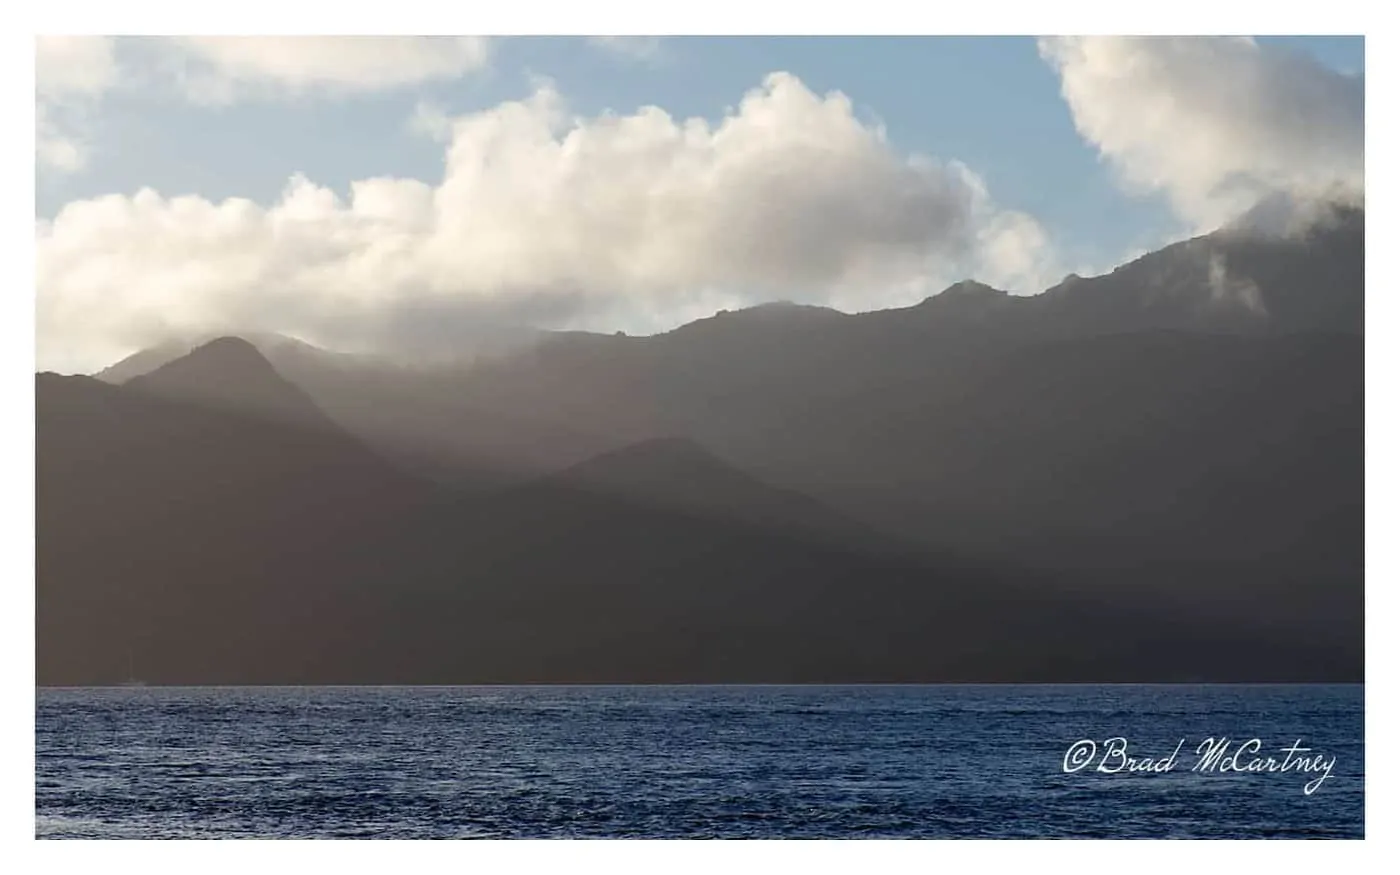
[35,36,1365,372]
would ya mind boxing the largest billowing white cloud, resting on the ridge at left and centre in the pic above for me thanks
[36,73,1049,368]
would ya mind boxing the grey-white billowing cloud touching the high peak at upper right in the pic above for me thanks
[1040,36,1365,230]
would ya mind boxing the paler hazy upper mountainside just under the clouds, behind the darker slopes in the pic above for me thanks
[105,209,1365,490]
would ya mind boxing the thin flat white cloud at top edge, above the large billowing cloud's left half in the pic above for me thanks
[162,36,490,104]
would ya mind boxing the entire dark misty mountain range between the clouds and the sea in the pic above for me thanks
[36,207,1365,683]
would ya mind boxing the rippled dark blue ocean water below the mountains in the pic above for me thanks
[35,686,1365,839]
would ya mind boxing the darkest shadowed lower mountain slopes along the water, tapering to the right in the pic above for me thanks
[36,366,1361,683]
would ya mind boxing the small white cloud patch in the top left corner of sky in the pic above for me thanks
[34,36,120,174]
